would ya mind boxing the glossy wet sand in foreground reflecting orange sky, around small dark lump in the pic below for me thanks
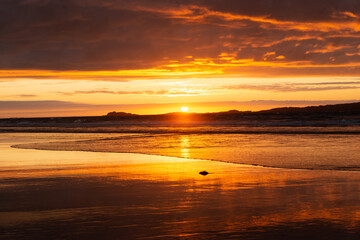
[0,134,360,239]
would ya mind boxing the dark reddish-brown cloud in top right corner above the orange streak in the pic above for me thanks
[200,0,360,22]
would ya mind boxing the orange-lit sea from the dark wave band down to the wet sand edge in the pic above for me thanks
[9,125,360,171]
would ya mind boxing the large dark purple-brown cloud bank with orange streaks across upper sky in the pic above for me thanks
[0,0,360,76]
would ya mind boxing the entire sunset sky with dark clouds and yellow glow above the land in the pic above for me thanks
[0,0,360,118]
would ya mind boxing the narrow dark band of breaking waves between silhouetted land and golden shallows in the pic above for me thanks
[0,122,360,134]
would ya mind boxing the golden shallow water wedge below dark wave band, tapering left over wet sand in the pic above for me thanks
[17,133,360,170]
